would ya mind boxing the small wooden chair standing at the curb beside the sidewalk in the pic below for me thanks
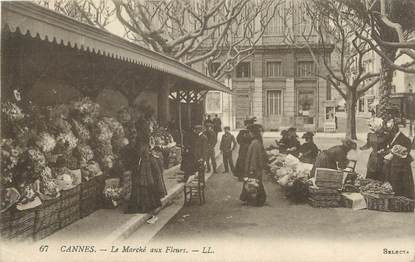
[183,166,206,205]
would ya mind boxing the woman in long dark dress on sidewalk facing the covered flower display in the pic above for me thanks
[126,108,165,213]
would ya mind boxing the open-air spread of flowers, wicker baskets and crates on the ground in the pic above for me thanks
[267,146,415,212]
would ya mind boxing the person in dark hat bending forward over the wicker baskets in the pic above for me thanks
[310,138,357,176]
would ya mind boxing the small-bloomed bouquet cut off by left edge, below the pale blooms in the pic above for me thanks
[0,139,23,186]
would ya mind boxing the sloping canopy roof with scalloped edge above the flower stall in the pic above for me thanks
[1,1,231,93]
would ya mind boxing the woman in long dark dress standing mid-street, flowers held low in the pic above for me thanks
[240,124,266,206]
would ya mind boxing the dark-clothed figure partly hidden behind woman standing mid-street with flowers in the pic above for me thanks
[233,118,256,181]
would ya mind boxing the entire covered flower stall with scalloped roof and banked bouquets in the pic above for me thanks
[0,2,228,241]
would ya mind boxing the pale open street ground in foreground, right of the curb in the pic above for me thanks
[153,138,415,243]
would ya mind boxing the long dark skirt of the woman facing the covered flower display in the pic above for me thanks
[126,157,164,213]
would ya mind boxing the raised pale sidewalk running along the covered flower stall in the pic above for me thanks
[41,144,222,243]
